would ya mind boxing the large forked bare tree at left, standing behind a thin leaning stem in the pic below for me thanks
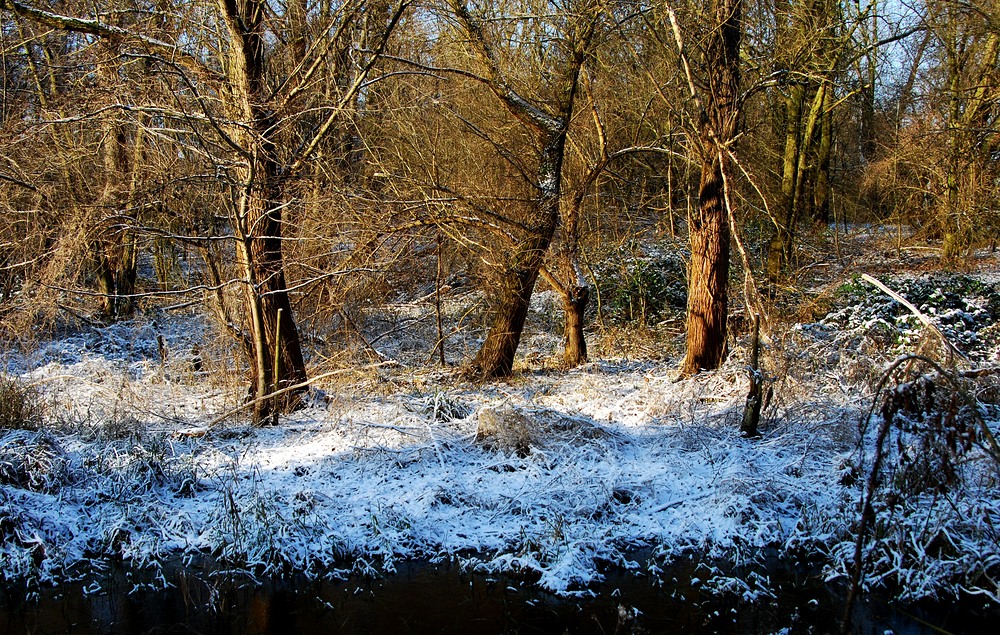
[0,0,407,422]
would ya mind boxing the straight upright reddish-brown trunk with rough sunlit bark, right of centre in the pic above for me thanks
[681,0,743,375]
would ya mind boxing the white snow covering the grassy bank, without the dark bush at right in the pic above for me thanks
[0,272,1000,598]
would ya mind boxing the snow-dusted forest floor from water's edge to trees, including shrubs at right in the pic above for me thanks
[0,229,1000,616]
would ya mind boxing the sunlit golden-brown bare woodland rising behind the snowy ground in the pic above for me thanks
[0,0,1000,408]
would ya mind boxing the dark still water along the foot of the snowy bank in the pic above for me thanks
[0,562,1000,635]
